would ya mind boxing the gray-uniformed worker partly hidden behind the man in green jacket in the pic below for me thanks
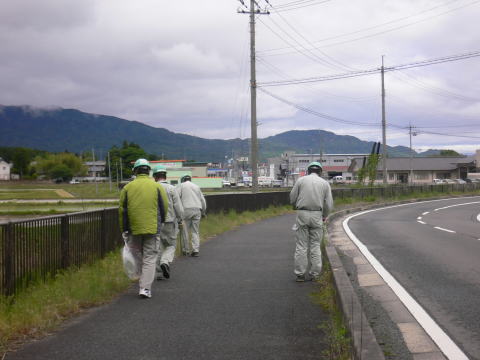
[153,165,183,280]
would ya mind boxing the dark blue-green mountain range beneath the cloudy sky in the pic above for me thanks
[0,105,434,161]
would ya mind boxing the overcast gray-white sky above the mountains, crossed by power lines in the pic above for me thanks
[0,0,480,153]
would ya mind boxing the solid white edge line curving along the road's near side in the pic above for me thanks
[343,200,472,360]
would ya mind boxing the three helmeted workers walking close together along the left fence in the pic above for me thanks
[119,159,207,298]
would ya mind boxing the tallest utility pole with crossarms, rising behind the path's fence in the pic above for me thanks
[237,0,270,194]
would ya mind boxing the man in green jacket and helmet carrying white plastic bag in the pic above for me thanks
[118,159,168,298]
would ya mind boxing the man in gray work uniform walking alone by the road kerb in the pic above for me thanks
[290,161,333,282]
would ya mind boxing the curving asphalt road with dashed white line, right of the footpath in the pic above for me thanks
[349,197,480,359]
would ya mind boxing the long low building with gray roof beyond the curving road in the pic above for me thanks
[377,156,477,184]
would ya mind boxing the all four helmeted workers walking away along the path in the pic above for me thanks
[119,159,333,298]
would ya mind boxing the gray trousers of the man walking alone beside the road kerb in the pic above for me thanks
[294,210,323,277]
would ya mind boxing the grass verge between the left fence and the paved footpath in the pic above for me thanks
[0,206,291,359]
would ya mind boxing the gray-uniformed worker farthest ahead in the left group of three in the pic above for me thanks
[177,175,207,257]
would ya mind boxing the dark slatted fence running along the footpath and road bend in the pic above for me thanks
[0,184,480,296]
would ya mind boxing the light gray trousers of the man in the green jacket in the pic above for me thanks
[128,234,158,289]
